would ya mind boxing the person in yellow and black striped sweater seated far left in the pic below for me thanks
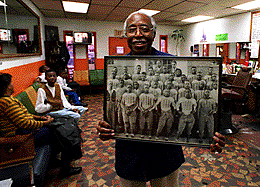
[0,73,82,178]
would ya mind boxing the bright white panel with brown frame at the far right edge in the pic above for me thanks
[250,11,260,58]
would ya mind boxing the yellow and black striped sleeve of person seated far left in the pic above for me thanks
[0,97,44,129]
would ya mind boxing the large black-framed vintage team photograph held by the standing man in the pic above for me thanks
[104,56,222,147]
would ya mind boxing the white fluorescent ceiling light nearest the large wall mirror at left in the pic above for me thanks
[62,1,89,13]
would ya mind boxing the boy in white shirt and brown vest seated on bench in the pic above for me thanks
[35,69,88,121]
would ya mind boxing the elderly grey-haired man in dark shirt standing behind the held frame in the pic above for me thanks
[97,12,225,187]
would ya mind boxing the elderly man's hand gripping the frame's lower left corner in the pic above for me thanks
[97,121,115,141]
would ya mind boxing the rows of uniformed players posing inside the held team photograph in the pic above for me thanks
[106,61,218,141]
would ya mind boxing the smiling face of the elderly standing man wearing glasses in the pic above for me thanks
[126,13,155,55]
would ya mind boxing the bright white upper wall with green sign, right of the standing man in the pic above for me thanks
[181,13,251,56]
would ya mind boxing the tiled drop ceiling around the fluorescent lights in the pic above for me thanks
[27,0,260,26]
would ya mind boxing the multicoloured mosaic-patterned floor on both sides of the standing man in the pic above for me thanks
[45,93,260,187]
